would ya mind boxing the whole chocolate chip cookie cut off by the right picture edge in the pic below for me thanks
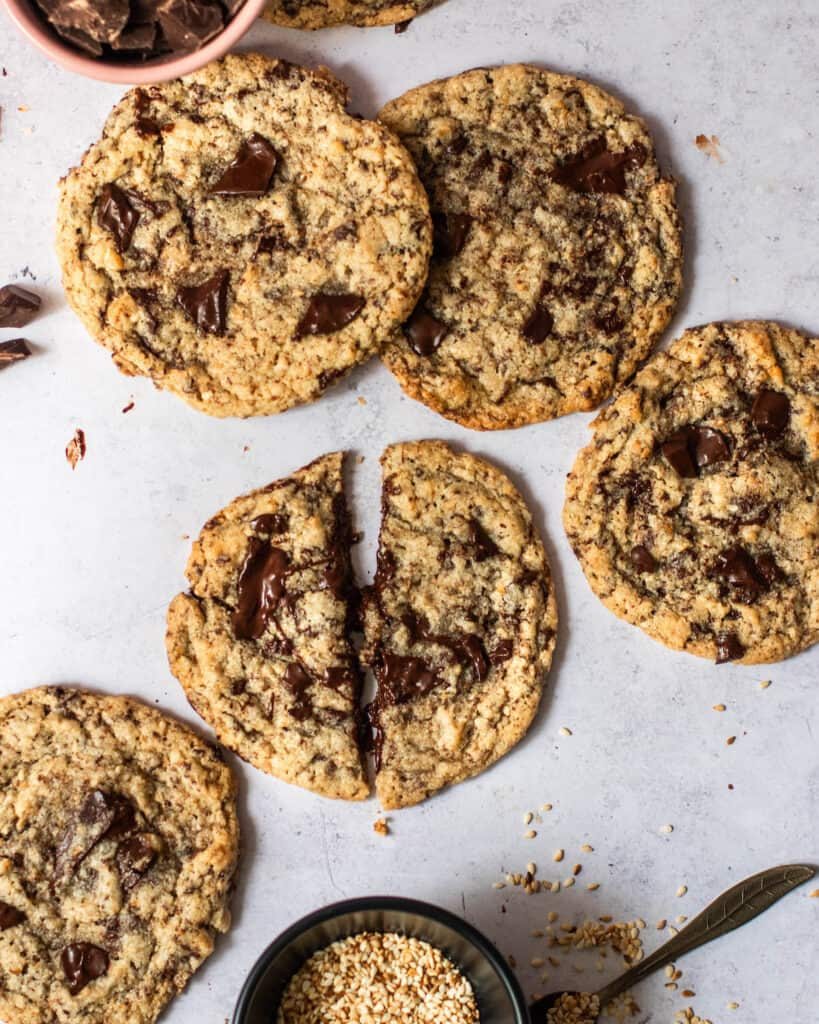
[564,323,819,665]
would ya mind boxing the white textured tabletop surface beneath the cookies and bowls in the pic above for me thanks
[0,0,819,1024]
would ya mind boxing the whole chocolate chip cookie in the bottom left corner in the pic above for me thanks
[0,687,239,1024]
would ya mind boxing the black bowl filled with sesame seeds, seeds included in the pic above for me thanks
[232,896,529,1024]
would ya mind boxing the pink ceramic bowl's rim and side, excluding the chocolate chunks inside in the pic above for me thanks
[3,0,267,85]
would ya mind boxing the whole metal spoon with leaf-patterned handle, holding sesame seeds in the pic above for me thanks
[530,864,816,1024]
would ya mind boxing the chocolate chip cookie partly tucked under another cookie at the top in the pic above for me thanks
[379,65,682,430]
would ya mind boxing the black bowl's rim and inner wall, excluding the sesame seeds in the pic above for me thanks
[233,896,529,1024]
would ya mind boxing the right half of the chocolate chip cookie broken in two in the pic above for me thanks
[361,441,557,809]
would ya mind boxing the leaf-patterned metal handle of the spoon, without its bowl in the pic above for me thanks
[598,864,816,1007]
